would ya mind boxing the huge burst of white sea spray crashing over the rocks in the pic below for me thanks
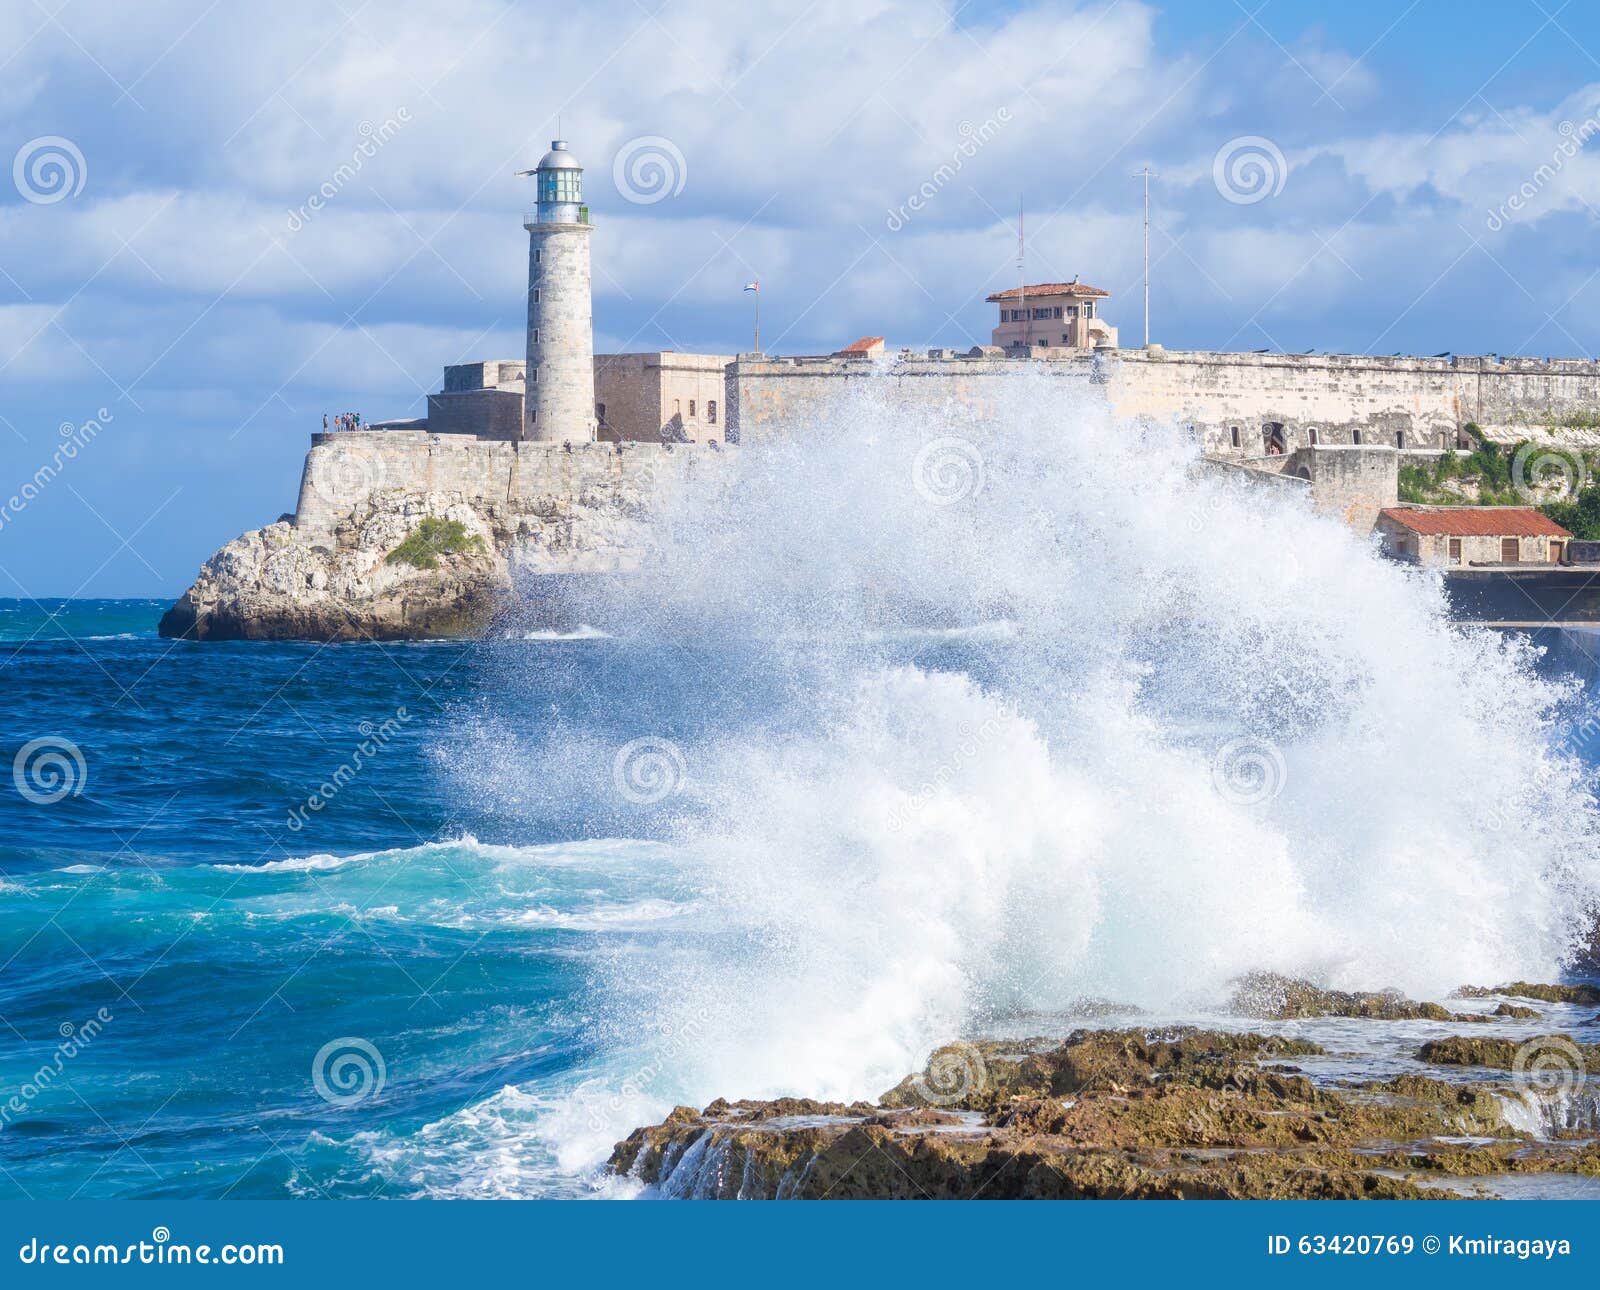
[464,371,1600,1152]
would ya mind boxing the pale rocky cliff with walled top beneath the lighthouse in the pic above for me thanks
[160,431,704,640]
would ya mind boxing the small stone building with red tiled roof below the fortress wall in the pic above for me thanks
[1378,506,1573,568]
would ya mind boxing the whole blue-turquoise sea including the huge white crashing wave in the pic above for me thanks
[9,381,1600,1199]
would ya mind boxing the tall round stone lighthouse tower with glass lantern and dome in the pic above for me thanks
[522,139,595,443]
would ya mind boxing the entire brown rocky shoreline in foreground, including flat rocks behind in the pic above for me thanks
[608,976,1600,1199]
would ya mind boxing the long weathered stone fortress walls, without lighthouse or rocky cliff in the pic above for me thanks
[296,347,1600,547]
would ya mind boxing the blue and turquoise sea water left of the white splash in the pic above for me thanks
[0,602,1592,1197]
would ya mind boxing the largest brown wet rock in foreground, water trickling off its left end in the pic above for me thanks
[611,1028,1548,1199]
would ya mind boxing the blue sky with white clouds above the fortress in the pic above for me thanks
[0,0,1600,599]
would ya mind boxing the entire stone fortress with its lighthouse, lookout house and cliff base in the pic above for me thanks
[162,141,1600,639]
